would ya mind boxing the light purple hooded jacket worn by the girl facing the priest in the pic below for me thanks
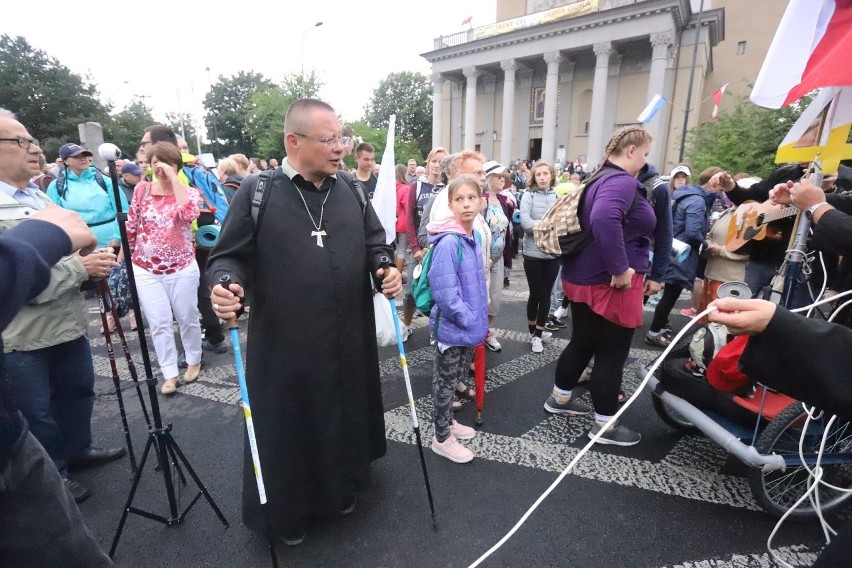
[428,219,488,347]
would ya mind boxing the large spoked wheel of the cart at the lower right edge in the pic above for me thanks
[748,402,852,519]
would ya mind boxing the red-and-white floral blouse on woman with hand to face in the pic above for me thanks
[127,182,201,274]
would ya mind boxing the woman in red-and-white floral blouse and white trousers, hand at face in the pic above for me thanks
[127,142,201,394]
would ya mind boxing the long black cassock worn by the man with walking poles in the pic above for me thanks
[207,169,393,534]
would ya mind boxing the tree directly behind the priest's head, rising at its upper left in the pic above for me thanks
[249,69,323,159]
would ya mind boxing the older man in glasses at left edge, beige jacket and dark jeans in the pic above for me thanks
[0,110,124,502]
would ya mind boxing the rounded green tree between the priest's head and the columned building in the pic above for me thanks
[364,71,432,161]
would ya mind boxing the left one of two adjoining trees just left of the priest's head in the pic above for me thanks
[204,71,272,156]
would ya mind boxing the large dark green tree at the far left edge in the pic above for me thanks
[0,34,110,151]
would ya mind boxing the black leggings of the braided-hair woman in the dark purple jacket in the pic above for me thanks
[555,302,636,416]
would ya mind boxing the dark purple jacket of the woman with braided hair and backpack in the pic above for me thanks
[562,162,664,285]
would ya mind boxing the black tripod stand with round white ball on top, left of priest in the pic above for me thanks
[98,144,229,557]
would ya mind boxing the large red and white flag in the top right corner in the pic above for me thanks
[750,0,852,108]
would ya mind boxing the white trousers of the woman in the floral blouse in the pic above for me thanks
[133,260,201,379]
